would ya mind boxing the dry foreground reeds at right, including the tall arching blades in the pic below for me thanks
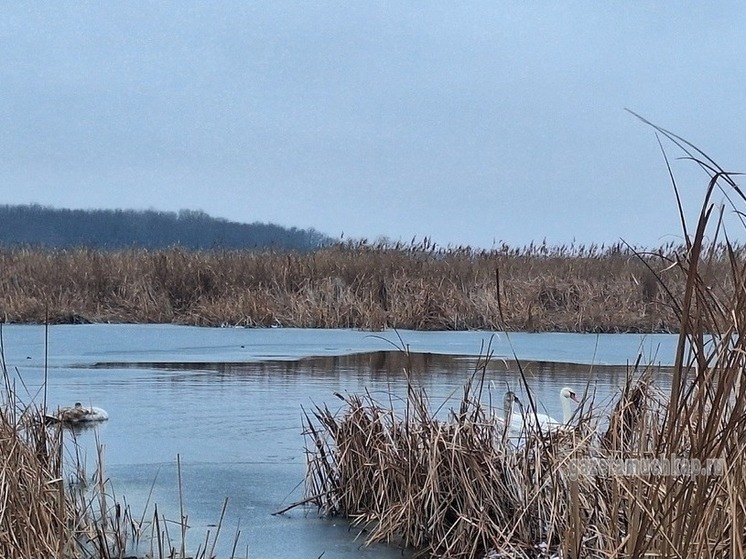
[294,129,746,559]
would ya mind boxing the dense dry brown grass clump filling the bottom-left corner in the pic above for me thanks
[0,358,147,559]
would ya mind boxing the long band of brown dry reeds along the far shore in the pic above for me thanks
[0,241,733,332]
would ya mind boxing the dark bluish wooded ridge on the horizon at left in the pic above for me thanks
[0,205,331,251]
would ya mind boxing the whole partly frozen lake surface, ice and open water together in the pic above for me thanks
[2,325,676,559]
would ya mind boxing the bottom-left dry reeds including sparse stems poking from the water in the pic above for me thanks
[0,344,239,559]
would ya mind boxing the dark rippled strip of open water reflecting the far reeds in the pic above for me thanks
[90,351,671,411]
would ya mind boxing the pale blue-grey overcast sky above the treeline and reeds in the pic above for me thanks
[0,0,746,248]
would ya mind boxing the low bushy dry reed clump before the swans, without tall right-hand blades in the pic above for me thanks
[306,350,640,557]
